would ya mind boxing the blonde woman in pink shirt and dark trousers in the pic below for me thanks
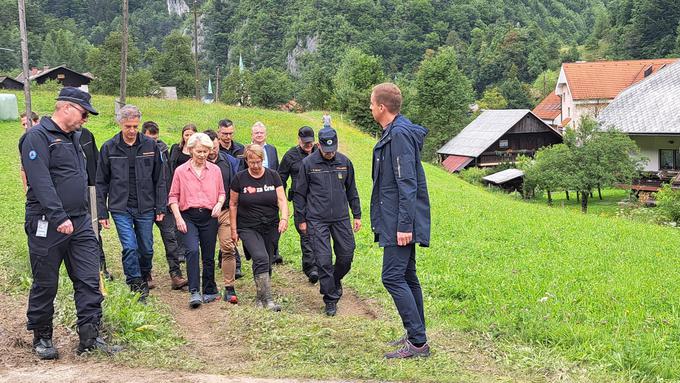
[168,133,226,308]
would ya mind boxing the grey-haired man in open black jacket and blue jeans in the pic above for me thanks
[97,105,168,303]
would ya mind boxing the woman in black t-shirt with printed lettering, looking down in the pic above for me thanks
[229,144,288,311]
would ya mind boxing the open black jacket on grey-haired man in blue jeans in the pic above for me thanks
[97,133,168,219]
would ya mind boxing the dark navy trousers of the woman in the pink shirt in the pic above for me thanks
[182,208,217,294]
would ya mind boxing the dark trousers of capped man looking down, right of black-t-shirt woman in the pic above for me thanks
[307,219,355,303]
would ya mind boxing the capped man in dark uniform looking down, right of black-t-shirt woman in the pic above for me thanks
[293,128,361,316]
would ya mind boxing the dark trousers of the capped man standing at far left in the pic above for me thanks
[24,215,103,330]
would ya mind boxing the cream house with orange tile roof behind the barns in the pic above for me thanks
[533,59,678,127]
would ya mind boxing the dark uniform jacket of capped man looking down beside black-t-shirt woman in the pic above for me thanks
[293,150,361,223]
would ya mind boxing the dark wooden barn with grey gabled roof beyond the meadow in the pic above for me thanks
[437,109,562,172]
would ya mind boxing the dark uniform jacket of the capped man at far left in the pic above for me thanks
[19,117,89,225]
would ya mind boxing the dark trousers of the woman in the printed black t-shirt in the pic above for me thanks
[238,224,279,276]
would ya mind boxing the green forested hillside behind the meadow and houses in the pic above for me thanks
[0,0,680,156]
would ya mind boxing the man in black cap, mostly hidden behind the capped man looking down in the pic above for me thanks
[279,126,319,284]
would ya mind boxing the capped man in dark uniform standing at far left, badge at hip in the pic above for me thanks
[19,87,113,359]
